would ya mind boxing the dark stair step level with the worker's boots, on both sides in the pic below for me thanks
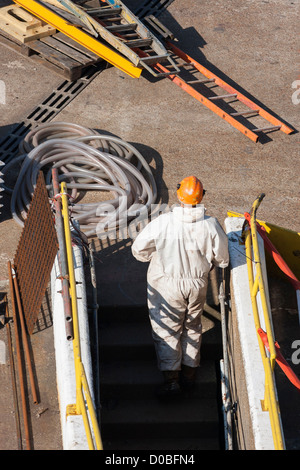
[100,358,217,400]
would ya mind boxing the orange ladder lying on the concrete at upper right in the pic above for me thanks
[150,41,294,142]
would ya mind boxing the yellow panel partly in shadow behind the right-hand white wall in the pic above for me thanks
[227,211,300,279]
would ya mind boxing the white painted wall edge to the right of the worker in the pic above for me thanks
[225,217,284,450]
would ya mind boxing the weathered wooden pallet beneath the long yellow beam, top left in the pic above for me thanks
[0,29,103,81]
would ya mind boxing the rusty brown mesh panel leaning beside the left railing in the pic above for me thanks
[14,171,58,334]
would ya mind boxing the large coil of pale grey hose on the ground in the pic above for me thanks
[5,122,157,237]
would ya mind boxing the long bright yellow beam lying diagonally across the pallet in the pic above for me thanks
[14,0,142,78]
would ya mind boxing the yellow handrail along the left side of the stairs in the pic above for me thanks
[60,182,103,450]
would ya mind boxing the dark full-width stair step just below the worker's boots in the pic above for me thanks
[101,397,220,440]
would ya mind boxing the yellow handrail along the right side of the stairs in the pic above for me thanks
[245,194,284,450]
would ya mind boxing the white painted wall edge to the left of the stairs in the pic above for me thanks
[51,241,95,450]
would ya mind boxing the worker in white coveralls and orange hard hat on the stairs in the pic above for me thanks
[132,176,229,397]
